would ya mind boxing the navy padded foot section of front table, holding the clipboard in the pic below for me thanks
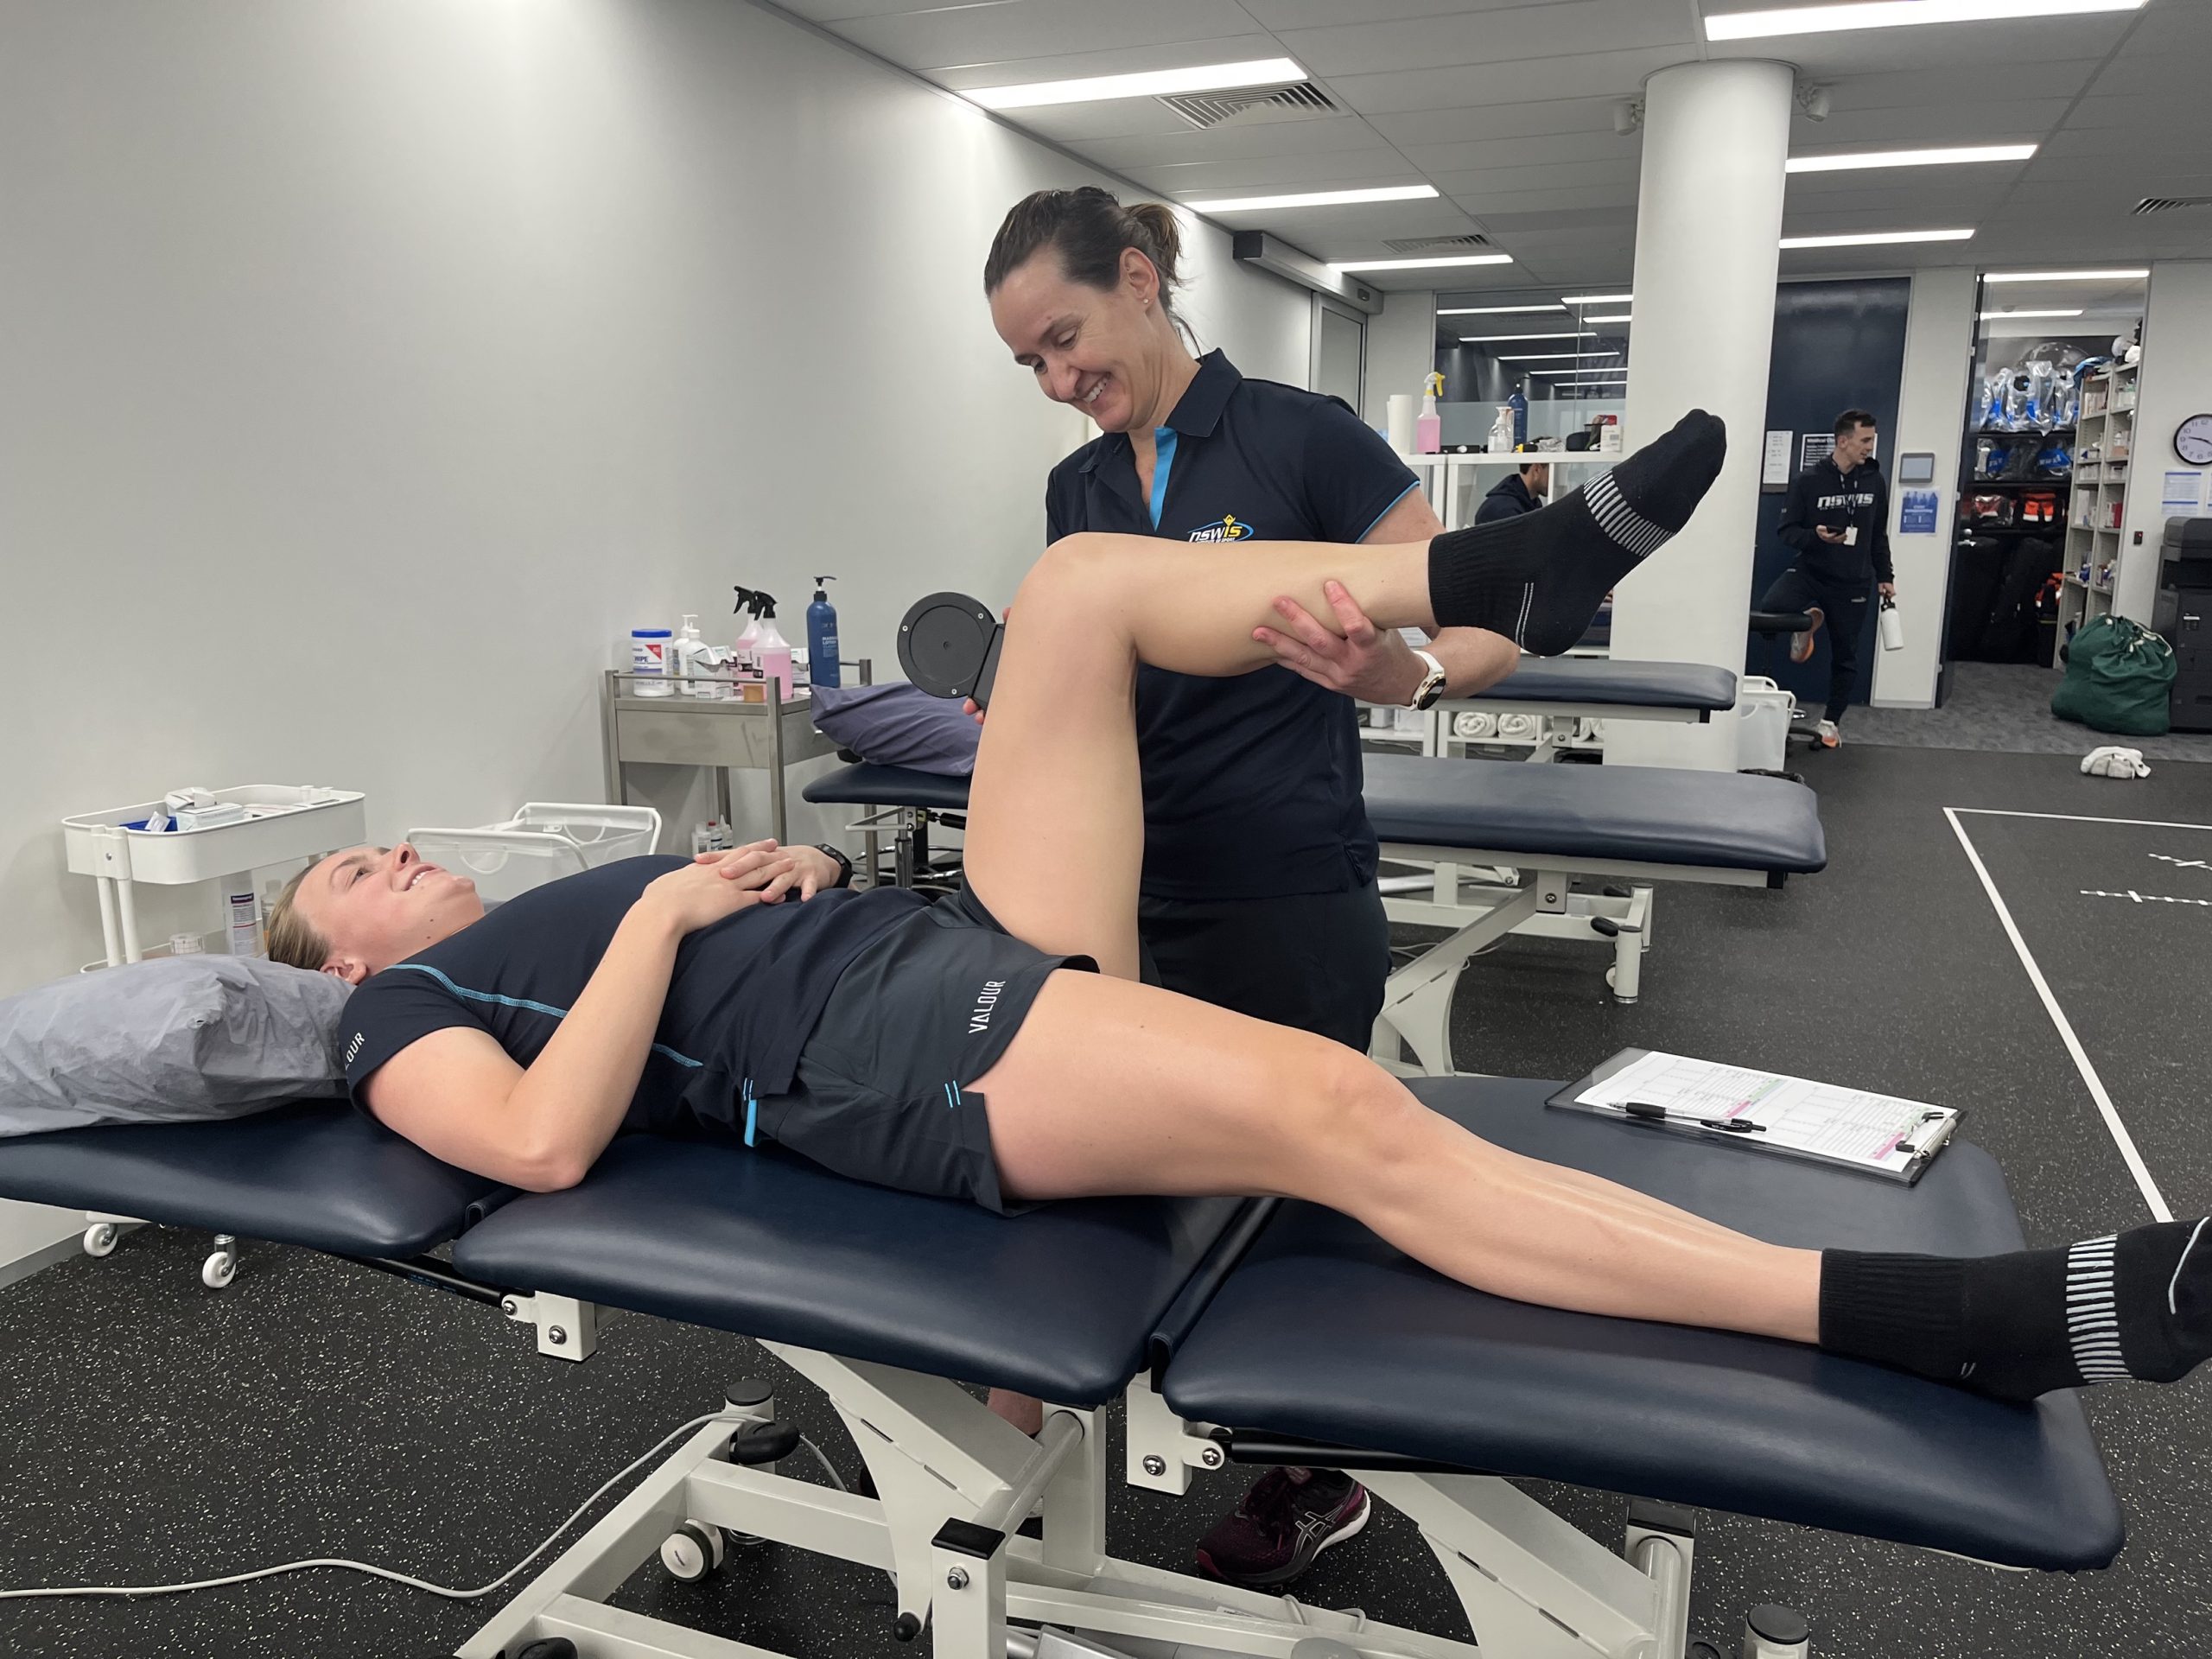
[1164,1077,2124,1571]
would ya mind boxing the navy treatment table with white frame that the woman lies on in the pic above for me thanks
[0,1079,2121,1659]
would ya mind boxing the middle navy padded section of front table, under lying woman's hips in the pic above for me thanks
[454,1135,1241,1407]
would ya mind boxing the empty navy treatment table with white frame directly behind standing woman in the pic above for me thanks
[805,760,1827,1075]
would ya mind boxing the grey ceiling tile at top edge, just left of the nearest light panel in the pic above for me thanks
[1283,0,1694,78]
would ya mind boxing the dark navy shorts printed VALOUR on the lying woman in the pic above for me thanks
[759,887,1097,1214]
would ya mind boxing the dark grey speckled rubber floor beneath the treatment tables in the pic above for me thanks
[0,746,2212,1659]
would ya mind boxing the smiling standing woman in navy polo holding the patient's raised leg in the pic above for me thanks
[984,186,1517,1586]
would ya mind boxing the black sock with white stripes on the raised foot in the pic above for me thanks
[1429,410,1727,657]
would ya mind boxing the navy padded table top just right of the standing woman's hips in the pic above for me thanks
[1367,754,1827,876]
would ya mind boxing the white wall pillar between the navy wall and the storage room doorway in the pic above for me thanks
[1872,265,1975,708]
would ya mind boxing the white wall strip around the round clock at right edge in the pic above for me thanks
[2113,259,2212,628]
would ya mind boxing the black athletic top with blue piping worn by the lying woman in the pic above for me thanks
[345,856,925,1135]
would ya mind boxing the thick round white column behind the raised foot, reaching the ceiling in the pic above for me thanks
[1606,60,1794,770]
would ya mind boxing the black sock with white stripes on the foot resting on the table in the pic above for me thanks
[1821,1221,2212,1400]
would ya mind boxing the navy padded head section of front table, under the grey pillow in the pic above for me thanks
[0,1099,509,1256]
